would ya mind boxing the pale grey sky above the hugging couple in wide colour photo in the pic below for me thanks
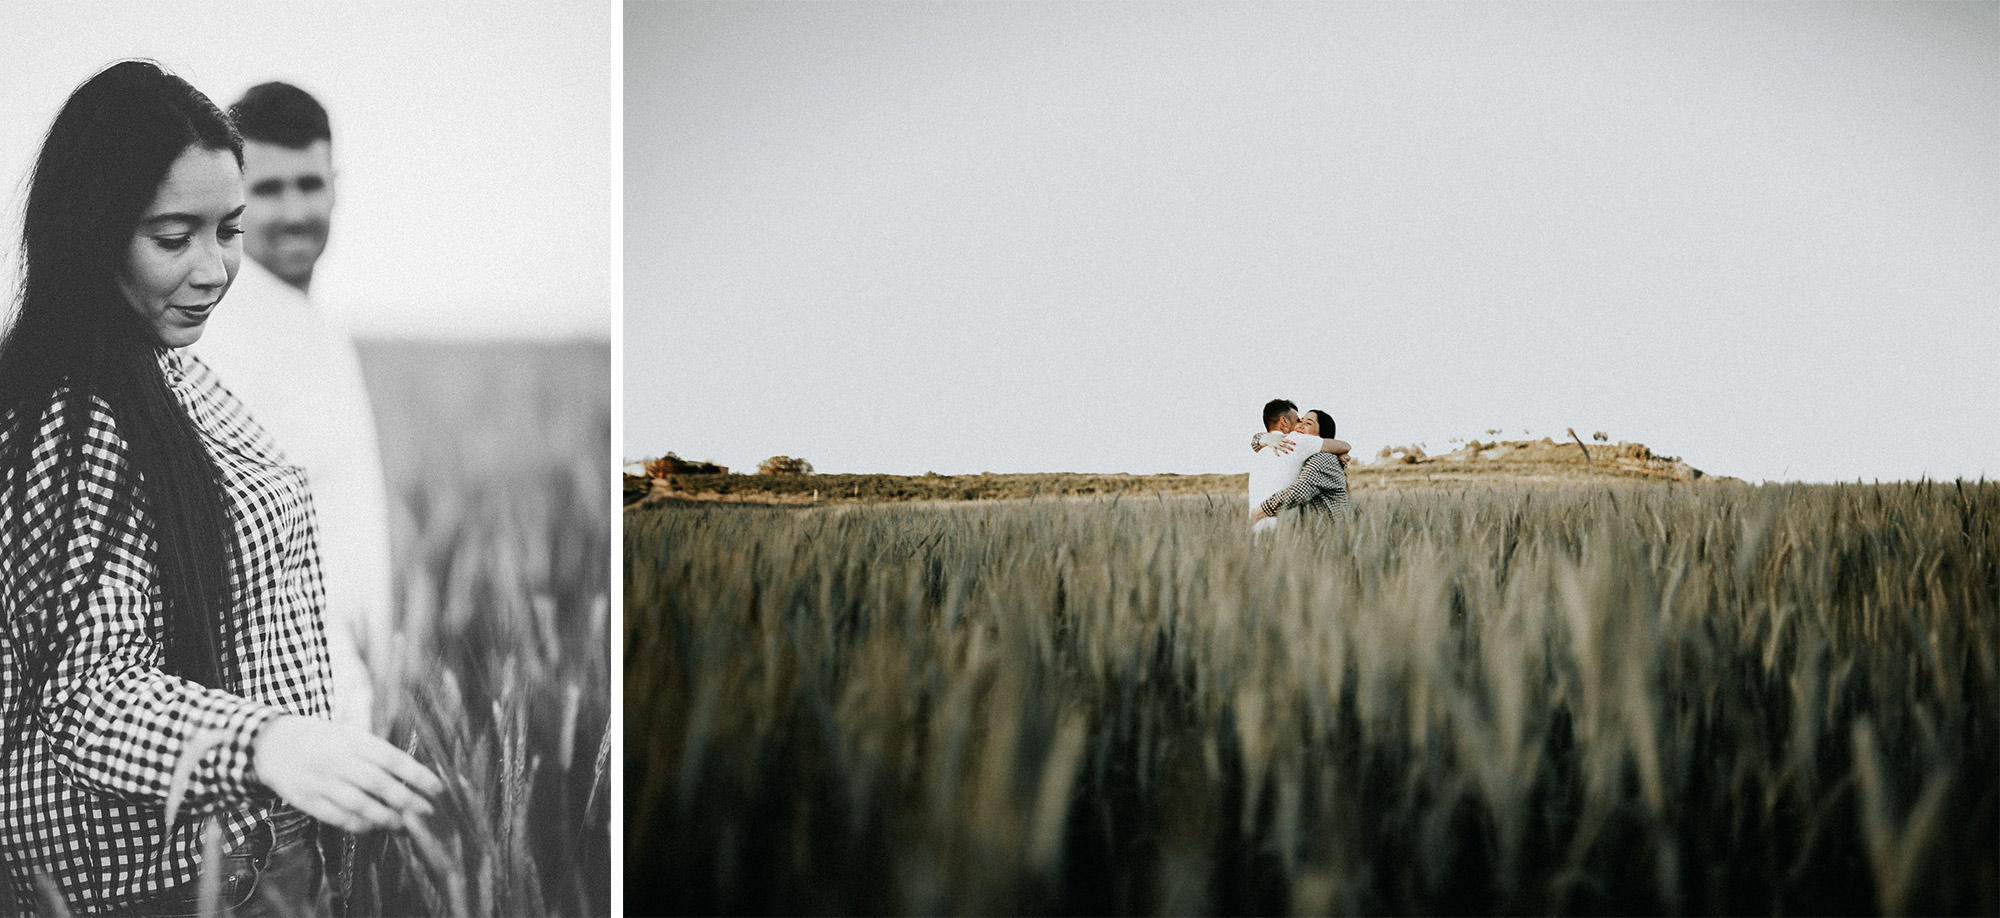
[644,2,2000,488]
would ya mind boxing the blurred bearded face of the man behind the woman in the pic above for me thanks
[244,140,334,290]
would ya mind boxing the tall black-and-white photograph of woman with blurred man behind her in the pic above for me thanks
[0,0,618,916]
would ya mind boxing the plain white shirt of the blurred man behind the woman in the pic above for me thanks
[194,258,392,728]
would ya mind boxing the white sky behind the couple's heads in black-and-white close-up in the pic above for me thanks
[0,0,616,338]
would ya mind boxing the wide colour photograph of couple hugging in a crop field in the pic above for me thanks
[616,0,2000,916]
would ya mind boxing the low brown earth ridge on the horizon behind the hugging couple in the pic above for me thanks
[624,436,1736,506]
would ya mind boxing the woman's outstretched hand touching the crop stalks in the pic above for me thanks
[252,714,444,832]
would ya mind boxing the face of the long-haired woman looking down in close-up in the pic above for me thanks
[118,146,244,348]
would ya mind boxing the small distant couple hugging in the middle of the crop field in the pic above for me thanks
[1250,398,1348,532]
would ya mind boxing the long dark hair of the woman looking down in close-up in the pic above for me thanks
[0,60,242,732]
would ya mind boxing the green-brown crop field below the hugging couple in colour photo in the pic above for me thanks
[624,482,2000,914]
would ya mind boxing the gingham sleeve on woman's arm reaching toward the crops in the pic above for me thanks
[28,398,280,816]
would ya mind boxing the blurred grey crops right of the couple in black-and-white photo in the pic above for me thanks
[358,344,610,916]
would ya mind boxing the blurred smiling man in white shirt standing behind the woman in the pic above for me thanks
[194,82,390,728]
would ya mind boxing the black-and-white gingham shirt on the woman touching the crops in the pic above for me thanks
[0,350,330,914]
